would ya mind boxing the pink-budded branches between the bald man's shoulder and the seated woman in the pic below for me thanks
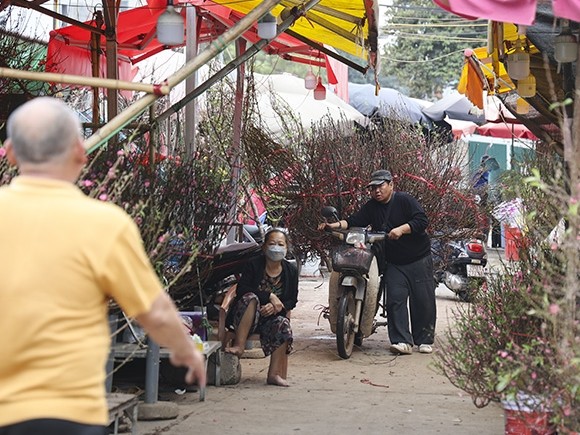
[79,124,232,312]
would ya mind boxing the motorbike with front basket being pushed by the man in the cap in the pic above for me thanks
[322,206,387,359]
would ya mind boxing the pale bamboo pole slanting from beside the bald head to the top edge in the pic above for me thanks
[85,0,279,153]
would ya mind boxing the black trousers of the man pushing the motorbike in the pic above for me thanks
[385,254,437,346]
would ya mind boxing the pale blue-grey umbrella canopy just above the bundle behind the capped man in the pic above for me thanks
[348,83,430,124]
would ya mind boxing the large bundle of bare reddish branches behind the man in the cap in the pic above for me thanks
[238,98,480,258]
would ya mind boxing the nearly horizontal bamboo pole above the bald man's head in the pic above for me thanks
[0,67,169,95]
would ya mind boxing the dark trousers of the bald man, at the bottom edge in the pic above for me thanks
[0,418,109,435]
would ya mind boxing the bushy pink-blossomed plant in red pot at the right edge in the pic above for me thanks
[435,161,580,434]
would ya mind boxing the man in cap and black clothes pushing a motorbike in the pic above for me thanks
[318,169,437,355]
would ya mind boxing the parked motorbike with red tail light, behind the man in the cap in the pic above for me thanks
[431,235,487,302]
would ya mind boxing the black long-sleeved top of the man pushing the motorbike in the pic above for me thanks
[346,192,431,265]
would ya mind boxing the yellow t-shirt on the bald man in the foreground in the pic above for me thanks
[0,177,162,426]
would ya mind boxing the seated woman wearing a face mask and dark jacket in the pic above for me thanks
[226,229,298,387]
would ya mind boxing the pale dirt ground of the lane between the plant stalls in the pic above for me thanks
[138,262,504,435]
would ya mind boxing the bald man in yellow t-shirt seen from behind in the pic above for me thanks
[0,97,205,435]
